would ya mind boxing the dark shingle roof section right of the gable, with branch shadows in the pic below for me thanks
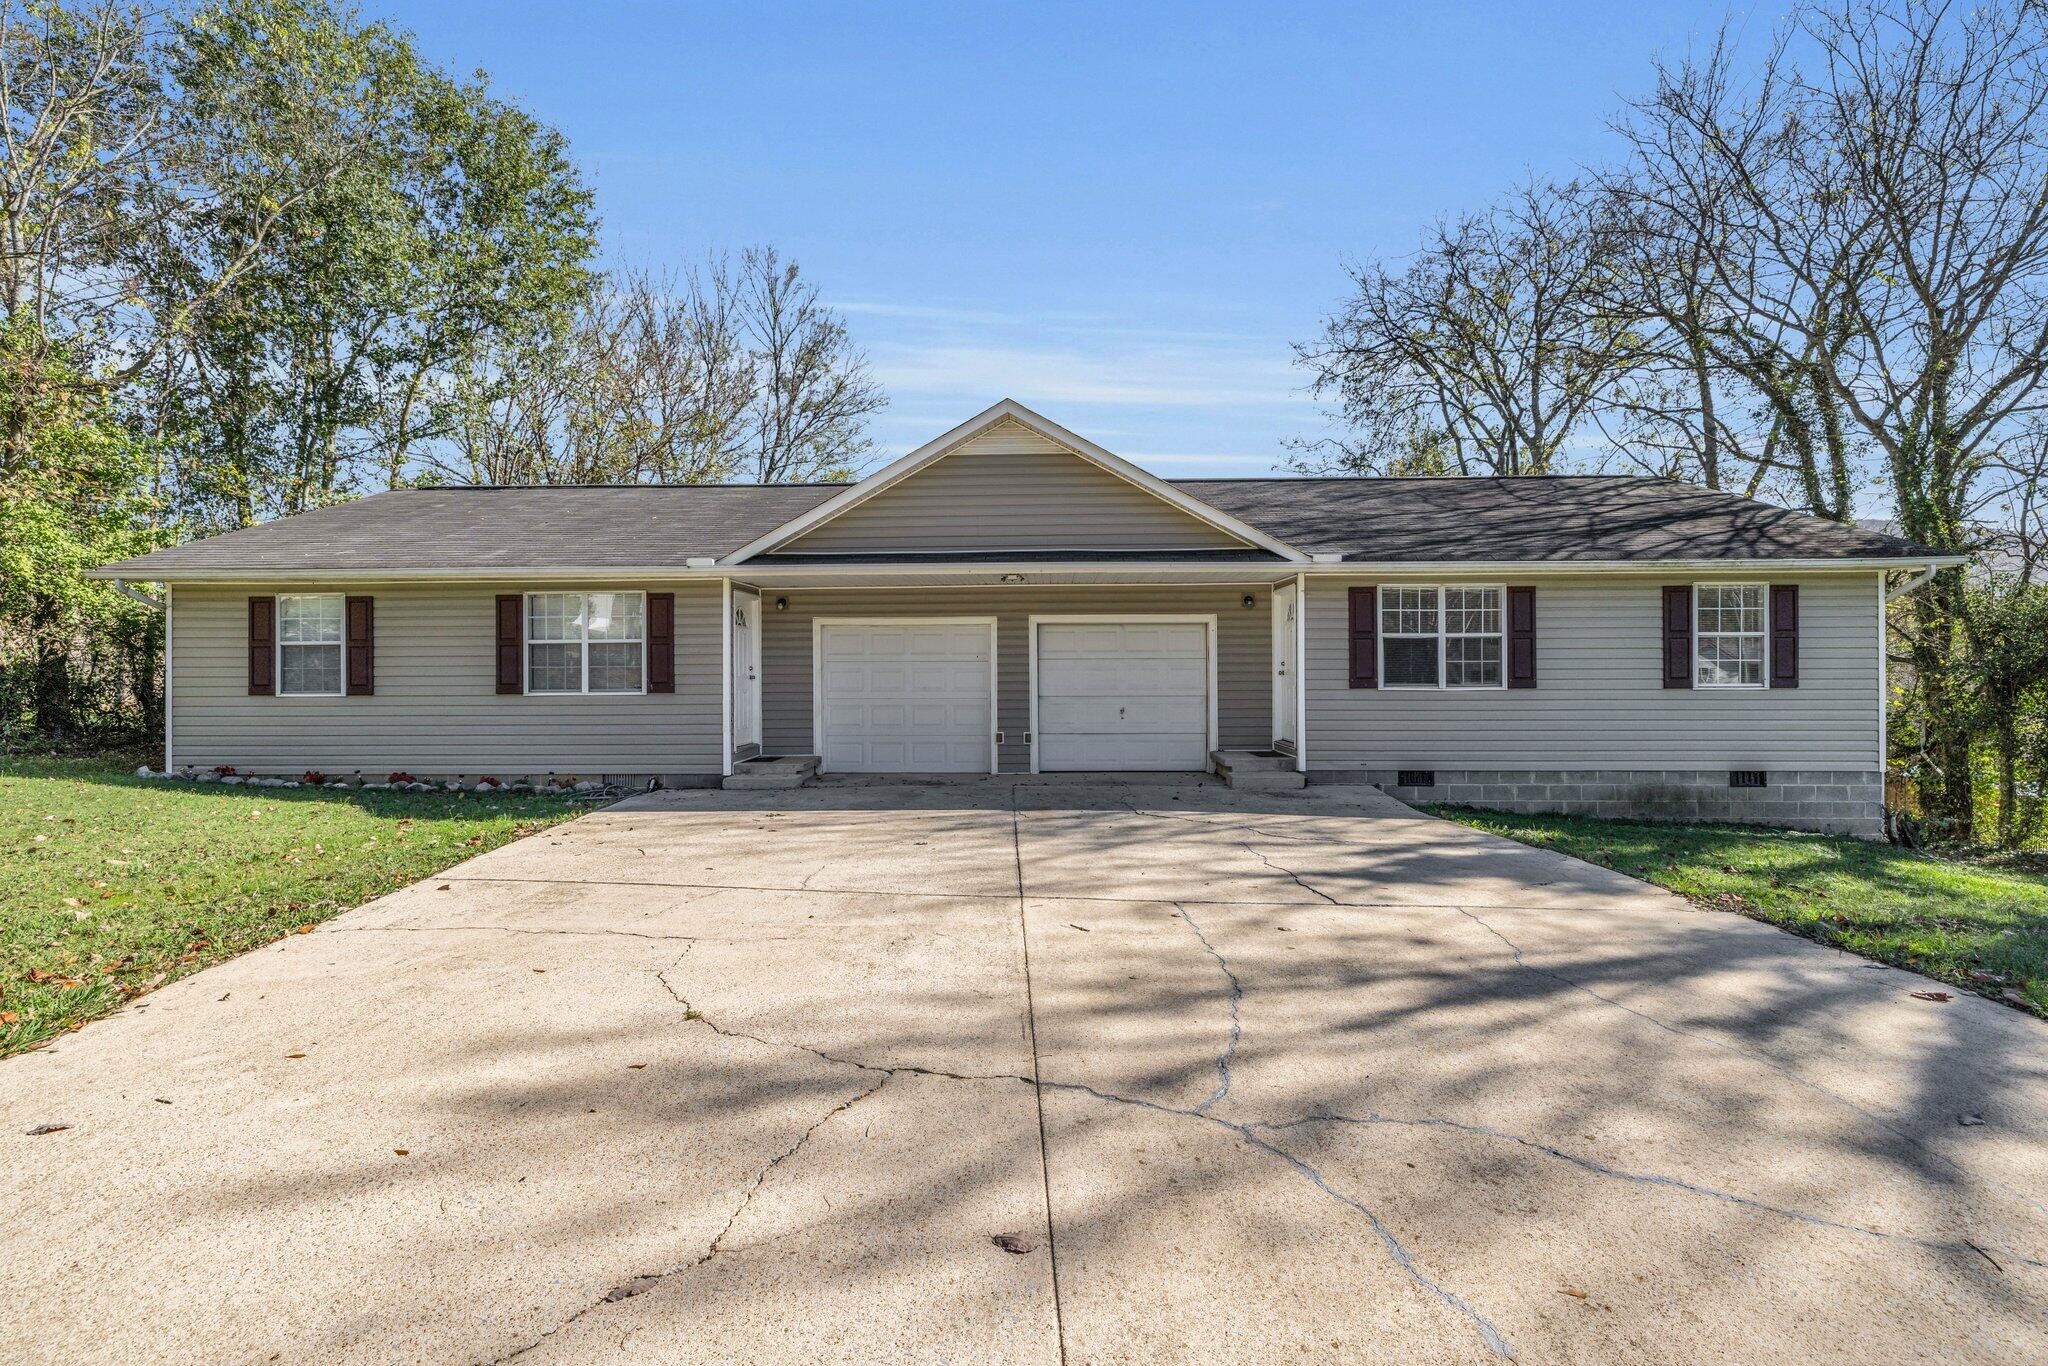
[1176,475,1933,563]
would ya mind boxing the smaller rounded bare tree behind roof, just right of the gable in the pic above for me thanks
[1296,184,1632,475]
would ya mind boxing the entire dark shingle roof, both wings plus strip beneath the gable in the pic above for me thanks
[104,475,1931,580]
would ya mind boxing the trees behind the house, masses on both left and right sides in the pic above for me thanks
[0,0,2048,846]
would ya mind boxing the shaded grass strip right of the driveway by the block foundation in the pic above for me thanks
[1430,807,2048,1016]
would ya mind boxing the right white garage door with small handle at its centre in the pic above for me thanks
[1038,621,1208,772]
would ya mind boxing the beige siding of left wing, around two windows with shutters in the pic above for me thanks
[172,582,723,778]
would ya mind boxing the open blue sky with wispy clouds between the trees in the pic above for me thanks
[380,0,1782,475]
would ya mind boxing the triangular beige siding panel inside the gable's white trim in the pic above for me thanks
[776,422,1245,551]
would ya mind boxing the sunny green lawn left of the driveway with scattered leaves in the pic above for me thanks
[0,758,586,1057]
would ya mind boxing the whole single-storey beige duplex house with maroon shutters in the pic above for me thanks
[98,401,1952,836]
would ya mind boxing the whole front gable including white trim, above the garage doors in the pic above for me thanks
[727,399,1305,563]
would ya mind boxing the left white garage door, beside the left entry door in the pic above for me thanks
[817,621,995,772]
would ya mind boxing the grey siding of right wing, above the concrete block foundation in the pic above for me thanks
[1307,573,1878,772]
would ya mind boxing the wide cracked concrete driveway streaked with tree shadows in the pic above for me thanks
[0,784,2048,1362]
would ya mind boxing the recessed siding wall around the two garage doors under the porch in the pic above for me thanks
[762,584,1272,772]
